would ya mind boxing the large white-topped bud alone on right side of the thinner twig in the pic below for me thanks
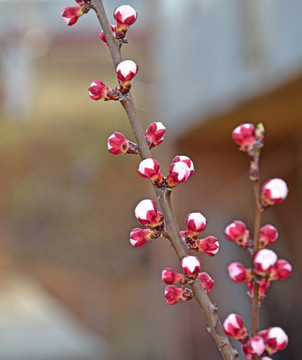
[261,178,288,206]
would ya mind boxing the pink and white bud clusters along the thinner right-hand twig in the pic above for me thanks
[223,124,292,360]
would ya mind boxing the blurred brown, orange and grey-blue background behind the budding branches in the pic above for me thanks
[0,0,302,360]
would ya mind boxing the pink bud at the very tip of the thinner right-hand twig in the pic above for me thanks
[232,124,256,155]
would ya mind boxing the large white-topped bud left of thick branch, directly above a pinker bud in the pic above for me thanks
[134,199,164,231]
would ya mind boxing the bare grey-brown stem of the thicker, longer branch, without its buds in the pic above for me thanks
[92,0,237,360]
